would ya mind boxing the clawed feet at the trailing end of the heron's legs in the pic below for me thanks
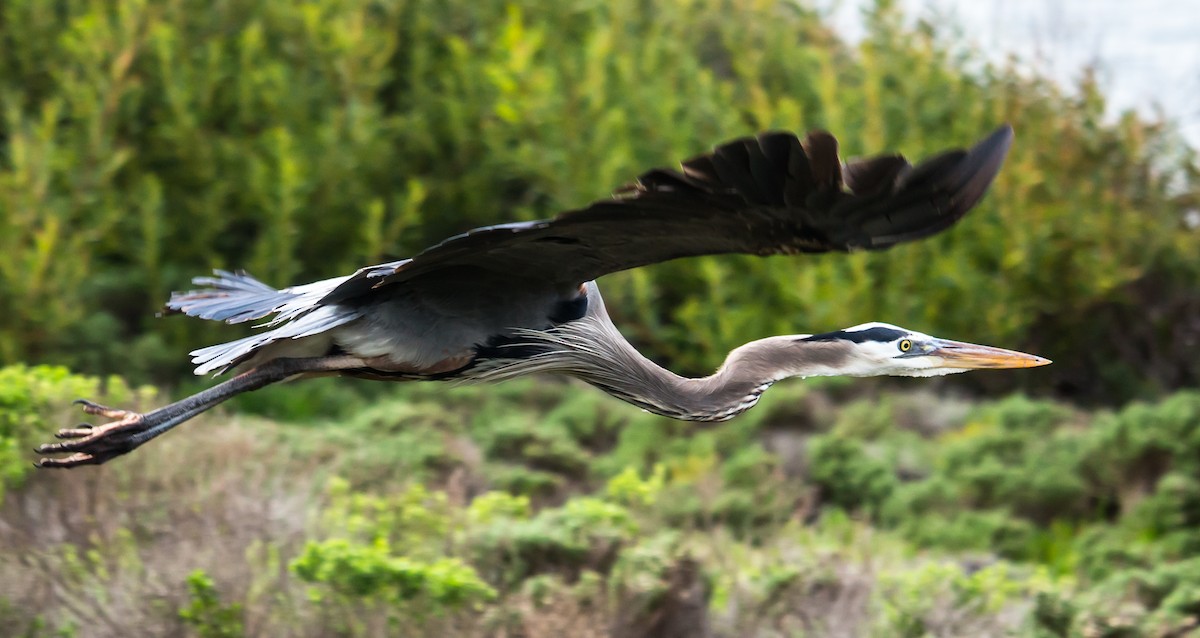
[37,399,150,468]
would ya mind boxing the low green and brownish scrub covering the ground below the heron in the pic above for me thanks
[0,357,1200,637]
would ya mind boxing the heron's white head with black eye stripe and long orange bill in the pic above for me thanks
[796,323,1050,377]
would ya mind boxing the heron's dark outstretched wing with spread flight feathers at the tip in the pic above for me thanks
[322,125,1013,303]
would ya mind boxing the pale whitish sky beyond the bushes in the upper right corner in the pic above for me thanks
[817,0,1200,146]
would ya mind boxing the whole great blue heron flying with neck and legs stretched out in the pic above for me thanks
[38,126,1049,468]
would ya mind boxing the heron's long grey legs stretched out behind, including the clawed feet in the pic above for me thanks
[37,355,365,468]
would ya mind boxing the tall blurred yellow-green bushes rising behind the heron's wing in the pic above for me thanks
[0,0,1200,398]
